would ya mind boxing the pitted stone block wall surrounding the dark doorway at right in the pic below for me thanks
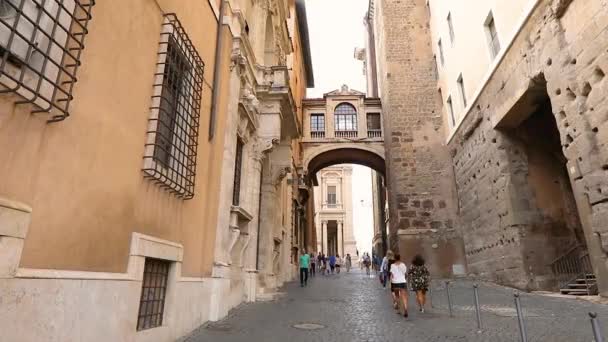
[449,0,608,295]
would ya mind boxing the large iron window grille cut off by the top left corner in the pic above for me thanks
[0,0,95,122]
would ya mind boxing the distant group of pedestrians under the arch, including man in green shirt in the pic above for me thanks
[299,251,352,287]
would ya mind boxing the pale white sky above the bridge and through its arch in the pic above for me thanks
[306,0,373,254]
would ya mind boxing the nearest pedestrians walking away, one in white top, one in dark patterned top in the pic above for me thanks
[380,250,430,317]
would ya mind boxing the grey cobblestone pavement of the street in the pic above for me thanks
[185,272,608,342]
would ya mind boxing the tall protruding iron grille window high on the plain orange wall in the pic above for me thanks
[143,14,204,199]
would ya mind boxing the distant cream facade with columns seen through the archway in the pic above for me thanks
[314,165,357,258]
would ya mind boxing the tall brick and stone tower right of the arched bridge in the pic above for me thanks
[374,0,464,275]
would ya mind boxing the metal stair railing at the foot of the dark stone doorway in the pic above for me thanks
[551,244,596,293]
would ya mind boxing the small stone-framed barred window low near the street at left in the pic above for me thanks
[137,258,171,331]
